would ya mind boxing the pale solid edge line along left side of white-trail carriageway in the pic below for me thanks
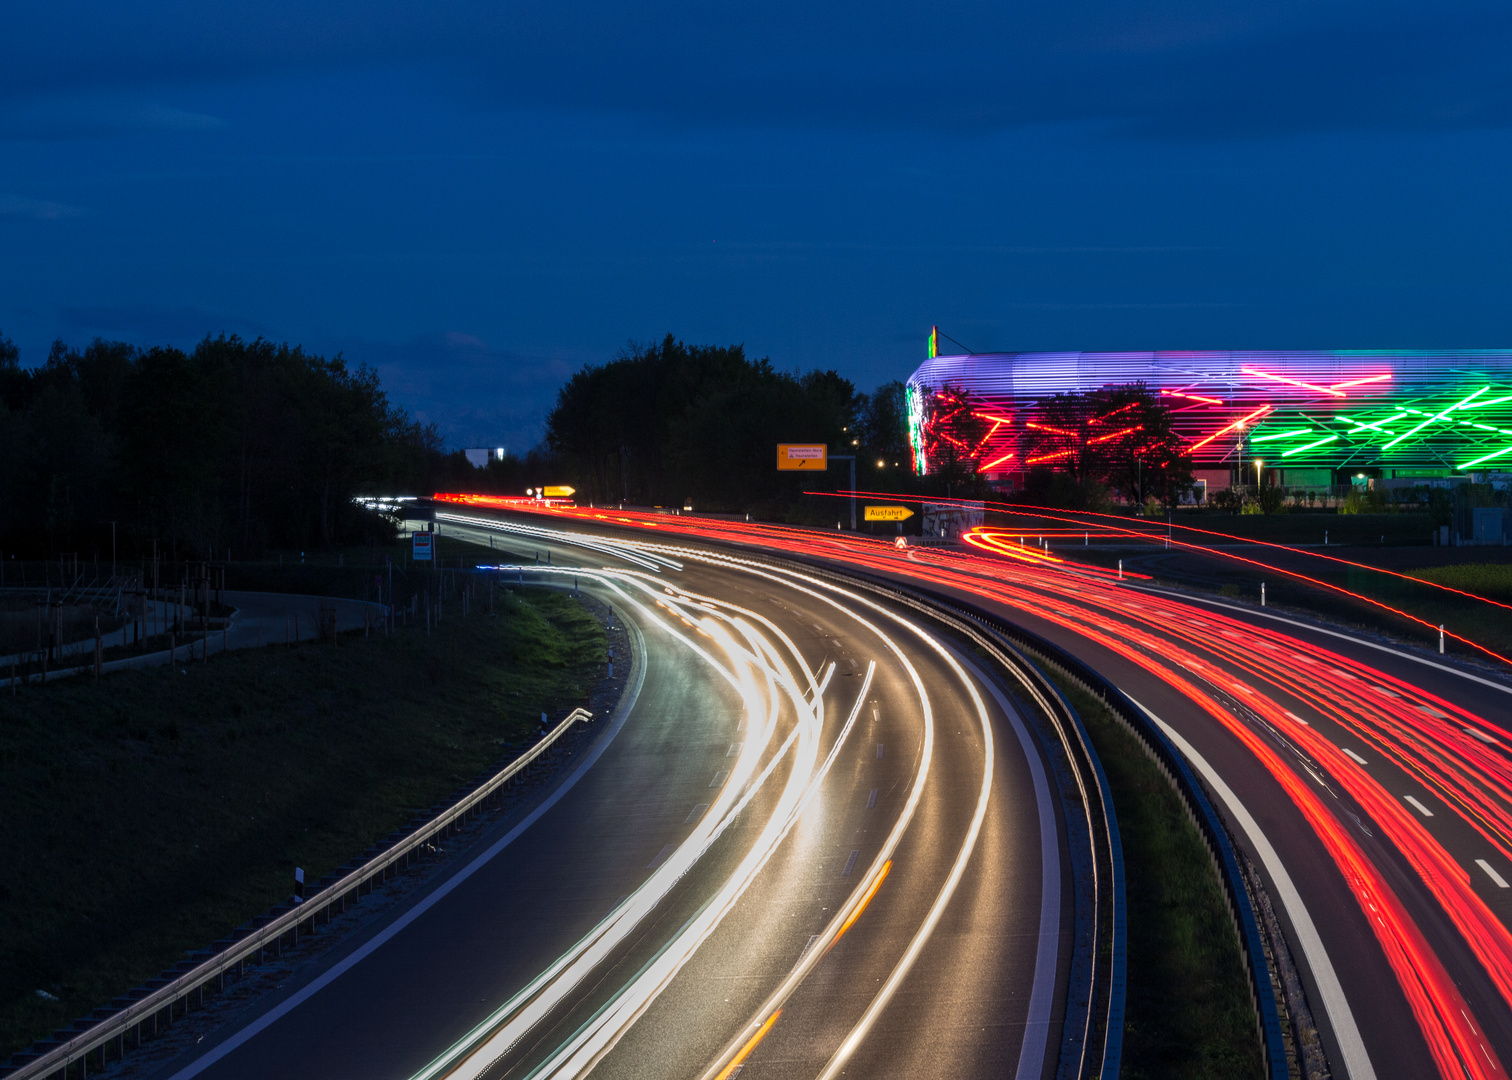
[169,595,646,1080]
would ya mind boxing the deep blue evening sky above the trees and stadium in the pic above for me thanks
[0,0,1512,451]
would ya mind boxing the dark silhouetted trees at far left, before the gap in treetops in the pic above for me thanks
[0,336,522,560]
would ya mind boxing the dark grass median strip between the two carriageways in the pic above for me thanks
[1052,675,1263,1080]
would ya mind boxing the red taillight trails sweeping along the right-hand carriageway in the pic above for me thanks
[437,496,1512,1080]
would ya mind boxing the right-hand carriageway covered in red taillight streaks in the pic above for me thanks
[441,508,1512,1078]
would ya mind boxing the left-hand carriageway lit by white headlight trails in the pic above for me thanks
[144,523,1075,1080]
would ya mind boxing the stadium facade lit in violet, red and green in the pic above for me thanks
[907,343,1512,487]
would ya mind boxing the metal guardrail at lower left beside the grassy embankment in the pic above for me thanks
[0,709,593,1080]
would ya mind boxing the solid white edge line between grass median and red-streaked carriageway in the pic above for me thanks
[1125,691,1376,1080]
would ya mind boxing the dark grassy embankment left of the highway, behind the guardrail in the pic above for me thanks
[0,577,605,1056]
